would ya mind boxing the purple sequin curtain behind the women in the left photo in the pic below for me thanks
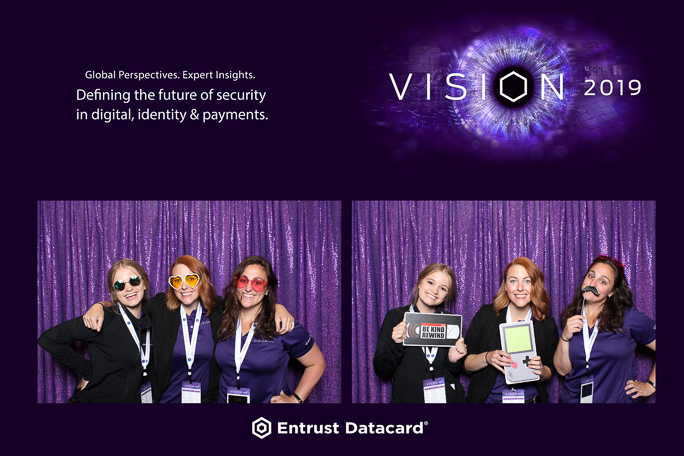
[36,201,341,403]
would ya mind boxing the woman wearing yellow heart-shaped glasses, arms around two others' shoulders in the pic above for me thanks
[84,255,294,403]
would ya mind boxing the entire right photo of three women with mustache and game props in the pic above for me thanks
[352,201,656,403]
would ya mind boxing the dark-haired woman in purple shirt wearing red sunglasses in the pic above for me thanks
[215,256,325,404]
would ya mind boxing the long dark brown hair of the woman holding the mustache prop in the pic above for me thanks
[561,255,634,333]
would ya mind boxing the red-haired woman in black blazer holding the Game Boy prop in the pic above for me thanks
[464,257,558,403]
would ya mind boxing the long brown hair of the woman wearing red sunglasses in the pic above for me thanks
[218,255,278,340]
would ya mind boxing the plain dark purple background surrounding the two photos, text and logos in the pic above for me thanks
[16,0,682,448]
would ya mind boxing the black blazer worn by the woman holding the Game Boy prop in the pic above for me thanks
[465,304,558,402]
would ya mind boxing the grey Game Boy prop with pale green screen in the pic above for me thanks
[499,321,539,385]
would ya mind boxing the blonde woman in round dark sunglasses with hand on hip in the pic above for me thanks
[38,259,152,402]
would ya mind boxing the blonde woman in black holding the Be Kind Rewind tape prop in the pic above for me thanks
[373,263,467,403]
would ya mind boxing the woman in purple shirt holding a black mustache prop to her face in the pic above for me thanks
[553,255,655,403]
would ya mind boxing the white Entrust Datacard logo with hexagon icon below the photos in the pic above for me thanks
[252,416,428,439]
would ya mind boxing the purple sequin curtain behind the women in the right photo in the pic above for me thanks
[352,201,656,403]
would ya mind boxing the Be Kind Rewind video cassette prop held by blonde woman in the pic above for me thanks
[404,312,462,347]
